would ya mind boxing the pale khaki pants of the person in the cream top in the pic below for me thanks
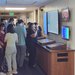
[5,47,17,71]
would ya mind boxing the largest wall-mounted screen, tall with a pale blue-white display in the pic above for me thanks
[48,10,59,34]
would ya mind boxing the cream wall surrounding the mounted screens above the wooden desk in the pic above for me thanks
[44,0,75,49]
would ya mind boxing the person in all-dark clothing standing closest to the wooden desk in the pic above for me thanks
[27,23,37,67]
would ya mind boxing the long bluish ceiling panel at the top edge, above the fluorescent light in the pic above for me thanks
[7,0,50,6]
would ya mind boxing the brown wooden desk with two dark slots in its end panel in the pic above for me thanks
[36,40,74,75]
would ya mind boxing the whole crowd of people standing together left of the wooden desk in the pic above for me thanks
[0,18,42,75]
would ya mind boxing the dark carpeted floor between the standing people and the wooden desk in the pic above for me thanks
[17,58,45,75]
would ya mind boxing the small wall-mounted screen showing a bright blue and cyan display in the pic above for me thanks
[61,26,70,40]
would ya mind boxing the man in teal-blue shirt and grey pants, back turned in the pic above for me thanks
[15,19,26,67]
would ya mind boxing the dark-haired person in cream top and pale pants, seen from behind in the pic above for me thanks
[4,24,18,75]
